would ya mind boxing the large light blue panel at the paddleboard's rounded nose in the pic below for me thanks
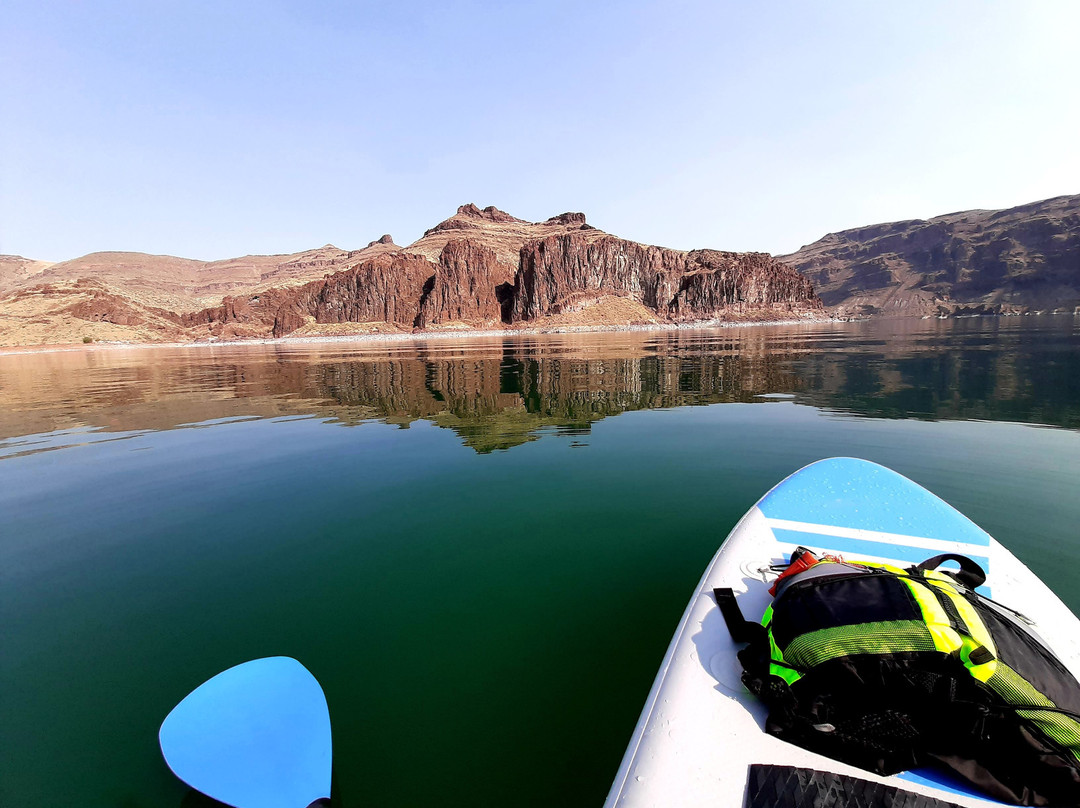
[758,457,990,547]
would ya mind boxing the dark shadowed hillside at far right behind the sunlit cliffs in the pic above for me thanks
[780,196,1080,317]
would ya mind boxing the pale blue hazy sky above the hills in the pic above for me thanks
[0,0,1080,261]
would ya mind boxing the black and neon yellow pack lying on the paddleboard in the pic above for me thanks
[716,548,1080,806]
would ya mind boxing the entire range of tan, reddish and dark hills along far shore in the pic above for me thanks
[6,196,1080,346]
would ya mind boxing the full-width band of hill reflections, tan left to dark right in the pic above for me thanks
[0,323,1080,453]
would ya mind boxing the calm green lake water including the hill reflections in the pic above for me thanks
[0,318,1080,808]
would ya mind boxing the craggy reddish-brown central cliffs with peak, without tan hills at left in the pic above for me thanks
[185,205,821,337]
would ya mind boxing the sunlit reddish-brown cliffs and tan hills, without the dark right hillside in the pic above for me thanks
[0,204,822,345]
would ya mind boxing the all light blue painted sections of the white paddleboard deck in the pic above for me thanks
[757,457,993,803]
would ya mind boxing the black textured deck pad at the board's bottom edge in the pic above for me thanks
[746,764,959,808]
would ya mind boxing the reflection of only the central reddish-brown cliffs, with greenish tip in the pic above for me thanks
[300,352,796,453]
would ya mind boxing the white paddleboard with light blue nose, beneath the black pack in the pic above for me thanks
[605,458,1080,808]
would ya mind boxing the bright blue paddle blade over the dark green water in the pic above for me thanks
[158,657,332,808]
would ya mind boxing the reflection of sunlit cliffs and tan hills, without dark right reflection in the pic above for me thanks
[0,334,799,453]
